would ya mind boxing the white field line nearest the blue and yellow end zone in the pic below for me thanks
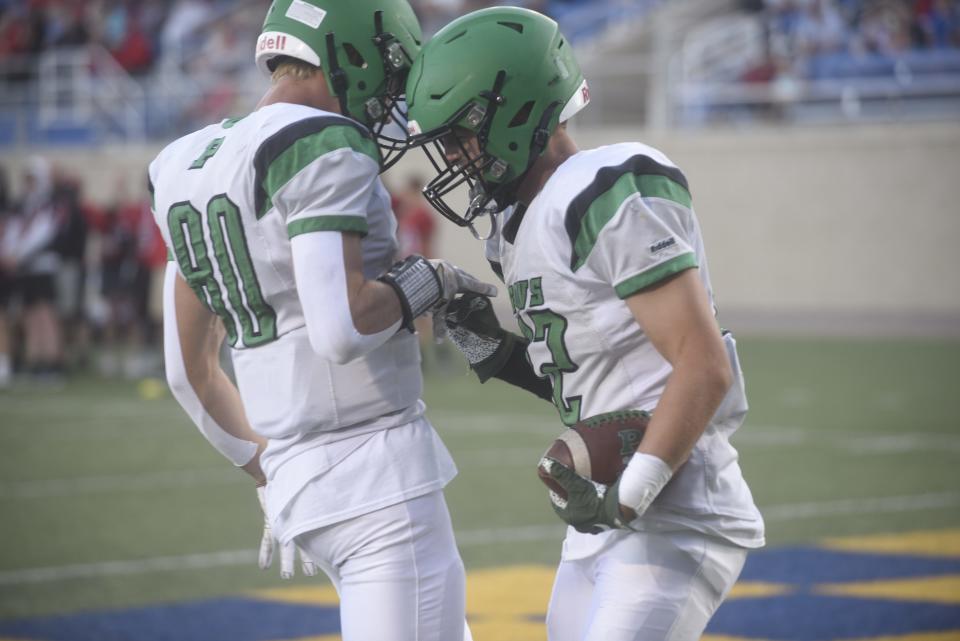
[0,492,960,586]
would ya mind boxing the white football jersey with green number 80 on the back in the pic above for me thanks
[149,104,452,528]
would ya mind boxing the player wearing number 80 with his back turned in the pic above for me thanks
[149,0,496,641]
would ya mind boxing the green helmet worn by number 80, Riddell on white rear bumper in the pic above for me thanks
[256,0,423,168]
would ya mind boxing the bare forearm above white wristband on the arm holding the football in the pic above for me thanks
[638,341,733,470]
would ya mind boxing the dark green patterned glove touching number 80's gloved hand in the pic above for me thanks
[444,292,518,383]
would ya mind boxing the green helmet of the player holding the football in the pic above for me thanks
[406,7,590,233]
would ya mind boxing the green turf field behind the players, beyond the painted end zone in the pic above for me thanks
[0,339,960,618]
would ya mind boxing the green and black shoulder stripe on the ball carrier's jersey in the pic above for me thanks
[564,155,691,271]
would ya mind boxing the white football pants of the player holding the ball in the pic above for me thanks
[547,532,747,641]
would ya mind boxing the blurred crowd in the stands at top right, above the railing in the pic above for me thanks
[745,0,960,82]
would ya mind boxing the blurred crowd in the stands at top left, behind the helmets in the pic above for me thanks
[0,0,556,138]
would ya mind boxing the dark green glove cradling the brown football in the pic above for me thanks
[541,457,633,534]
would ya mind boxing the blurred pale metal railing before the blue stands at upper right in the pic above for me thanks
[668,16,960,127]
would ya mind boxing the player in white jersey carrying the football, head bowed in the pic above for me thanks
[406,8,764,641]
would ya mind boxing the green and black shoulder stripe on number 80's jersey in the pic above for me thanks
[253,116,380,219]
